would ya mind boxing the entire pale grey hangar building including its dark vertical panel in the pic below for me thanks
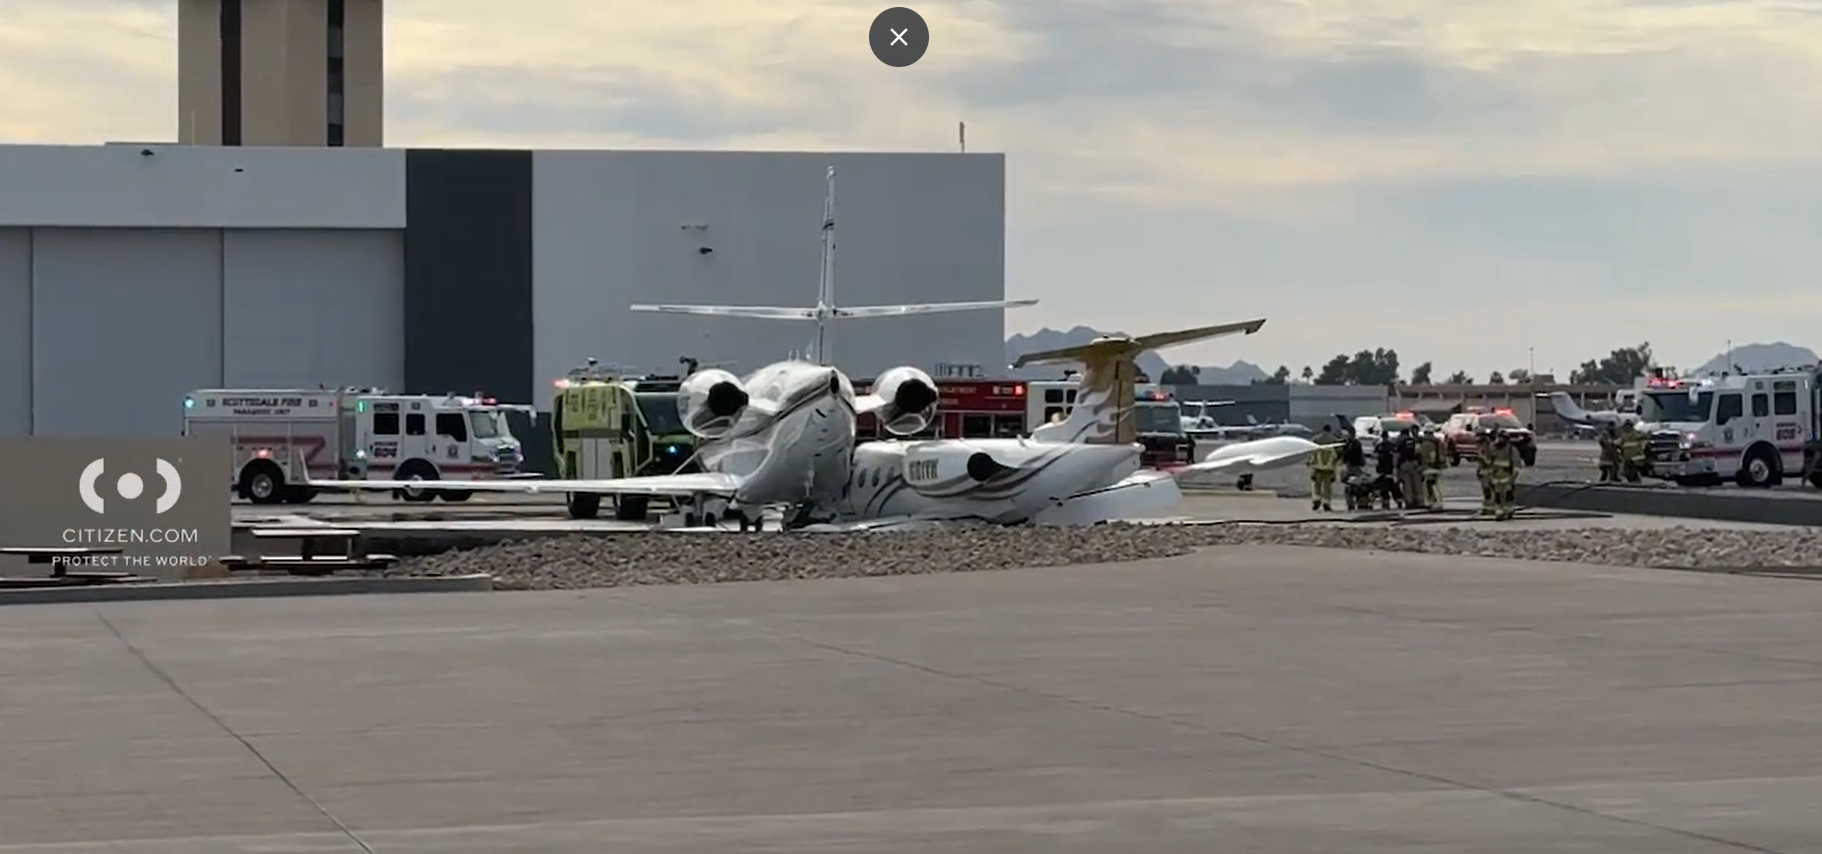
[0,144,1006,459]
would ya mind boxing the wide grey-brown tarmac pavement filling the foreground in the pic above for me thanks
[0,548,1822,854]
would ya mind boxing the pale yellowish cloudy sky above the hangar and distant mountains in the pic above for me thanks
[0,0,1822,375]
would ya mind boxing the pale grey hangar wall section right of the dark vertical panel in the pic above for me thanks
[532,151,1006,406]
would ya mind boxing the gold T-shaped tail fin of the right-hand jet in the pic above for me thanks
[1013,319,1264,444]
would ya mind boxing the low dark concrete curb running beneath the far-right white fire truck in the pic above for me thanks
[1518,483,1822,526]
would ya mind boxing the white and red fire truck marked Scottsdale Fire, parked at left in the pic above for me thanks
[184,388,527,504]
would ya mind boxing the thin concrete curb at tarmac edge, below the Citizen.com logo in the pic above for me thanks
[0,575,494,606]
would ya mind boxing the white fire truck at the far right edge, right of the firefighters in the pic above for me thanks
[1640,370,1817,486]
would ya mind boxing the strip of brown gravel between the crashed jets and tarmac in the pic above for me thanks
[388,524,1822,590]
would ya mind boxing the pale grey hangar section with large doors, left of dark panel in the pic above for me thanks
[0,146,404,435]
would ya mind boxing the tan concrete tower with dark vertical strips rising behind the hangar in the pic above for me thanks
[177,0,386,146]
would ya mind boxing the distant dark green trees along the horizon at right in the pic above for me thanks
[1159,342,1653,386]
